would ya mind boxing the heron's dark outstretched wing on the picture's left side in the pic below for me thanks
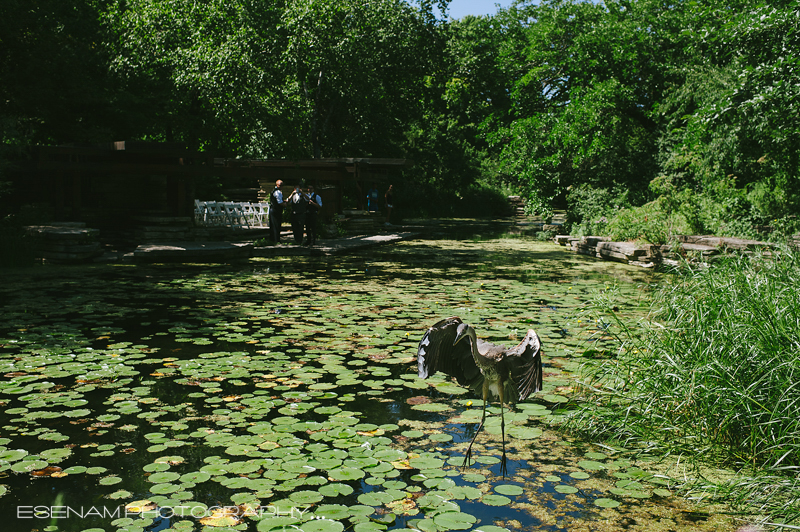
[417,316,483,388]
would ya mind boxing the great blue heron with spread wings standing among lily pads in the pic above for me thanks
[417,316,542,475]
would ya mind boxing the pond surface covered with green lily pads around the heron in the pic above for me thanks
[0,234,734,532]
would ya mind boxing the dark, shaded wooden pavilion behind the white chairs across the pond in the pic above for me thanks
[13,141,410,228]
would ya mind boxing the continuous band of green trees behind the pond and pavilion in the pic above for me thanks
[0,0,800,232]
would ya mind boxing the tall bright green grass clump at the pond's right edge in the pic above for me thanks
[570,251,800,521]
